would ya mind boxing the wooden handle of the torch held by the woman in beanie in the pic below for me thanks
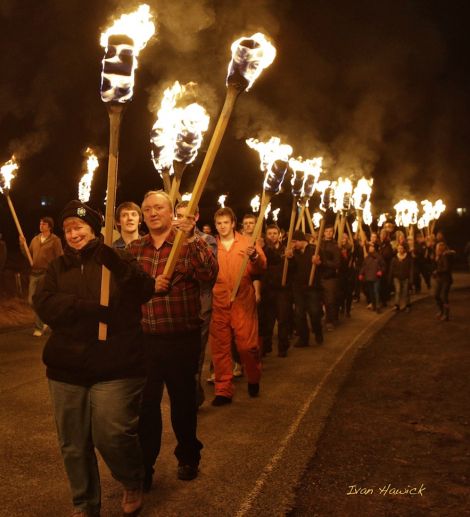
[98,104,124,341]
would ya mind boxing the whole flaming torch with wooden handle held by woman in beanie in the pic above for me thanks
[98,4,155,341]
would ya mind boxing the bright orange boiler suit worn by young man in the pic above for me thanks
[209,232,267,398]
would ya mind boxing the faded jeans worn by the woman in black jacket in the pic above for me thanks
[49,378,145,513]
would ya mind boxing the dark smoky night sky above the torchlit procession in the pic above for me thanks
[0,0,470,241]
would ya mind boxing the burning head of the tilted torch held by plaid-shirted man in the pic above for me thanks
[227,32,276,91]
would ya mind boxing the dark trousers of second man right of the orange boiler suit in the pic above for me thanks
[294,287,323,345]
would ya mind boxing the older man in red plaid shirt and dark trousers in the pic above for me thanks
[127,191,218,491]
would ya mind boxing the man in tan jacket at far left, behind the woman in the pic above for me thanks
[20,217,64,337]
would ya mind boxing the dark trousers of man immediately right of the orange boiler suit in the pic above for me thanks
[260,289,292,352]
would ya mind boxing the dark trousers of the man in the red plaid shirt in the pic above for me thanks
[139,329,202,469]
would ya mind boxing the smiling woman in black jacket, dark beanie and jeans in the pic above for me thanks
[34,201,155,517]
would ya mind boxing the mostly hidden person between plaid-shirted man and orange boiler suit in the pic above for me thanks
[175,201,217,407]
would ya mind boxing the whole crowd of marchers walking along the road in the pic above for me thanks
[12,191,454,517]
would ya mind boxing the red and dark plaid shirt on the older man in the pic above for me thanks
[127,230,218,334]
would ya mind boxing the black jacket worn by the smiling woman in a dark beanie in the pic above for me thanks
[33,239,155,385]
